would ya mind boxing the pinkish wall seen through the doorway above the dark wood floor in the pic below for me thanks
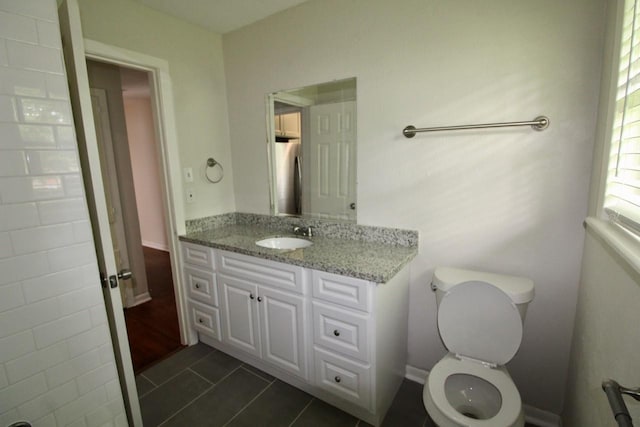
[124,93,169,251]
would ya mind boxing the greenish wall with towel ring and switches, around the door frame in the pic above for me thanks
[79,0,235,219]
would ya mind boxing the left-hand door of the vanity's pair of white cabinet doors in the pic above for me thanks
[218,274,260,357]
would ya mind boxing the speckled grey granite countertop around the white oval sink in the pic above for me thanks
[180,224,418,283]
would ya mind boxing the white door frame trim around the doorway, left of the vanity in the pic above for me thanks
[84,38,192,345]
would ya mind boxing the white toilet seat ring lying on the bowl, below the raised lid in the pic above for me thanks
[423,354,524,427]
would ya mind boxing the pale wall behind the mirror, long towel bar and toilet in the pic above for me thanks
[223,0,605,414]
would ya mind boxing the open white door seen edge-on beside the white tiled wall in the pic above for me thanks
[58,0,142,426]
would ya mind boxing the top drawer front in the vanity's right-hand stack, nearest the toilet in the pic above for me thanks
[311,270,374,312]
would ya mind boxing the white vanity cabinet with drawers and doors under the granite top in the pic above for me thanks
[183,242,409,426]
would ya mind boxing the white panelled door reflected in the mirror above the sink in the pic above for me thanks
[303,101,356,220]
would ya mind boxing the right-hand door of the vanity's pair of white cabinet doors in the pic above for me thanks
[258,287,307,379]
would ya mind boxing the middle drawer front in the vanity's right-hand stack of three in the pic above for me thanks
[313,301,371,362]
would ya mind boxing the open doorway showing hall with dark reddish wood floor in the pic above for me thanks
[87,60,182,373]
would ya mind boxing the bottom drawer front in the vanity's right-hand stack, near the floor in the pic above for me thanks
[315,348,371,409]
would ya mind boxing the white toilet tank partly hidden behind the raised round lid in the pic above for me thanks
[431,267,534,320]
